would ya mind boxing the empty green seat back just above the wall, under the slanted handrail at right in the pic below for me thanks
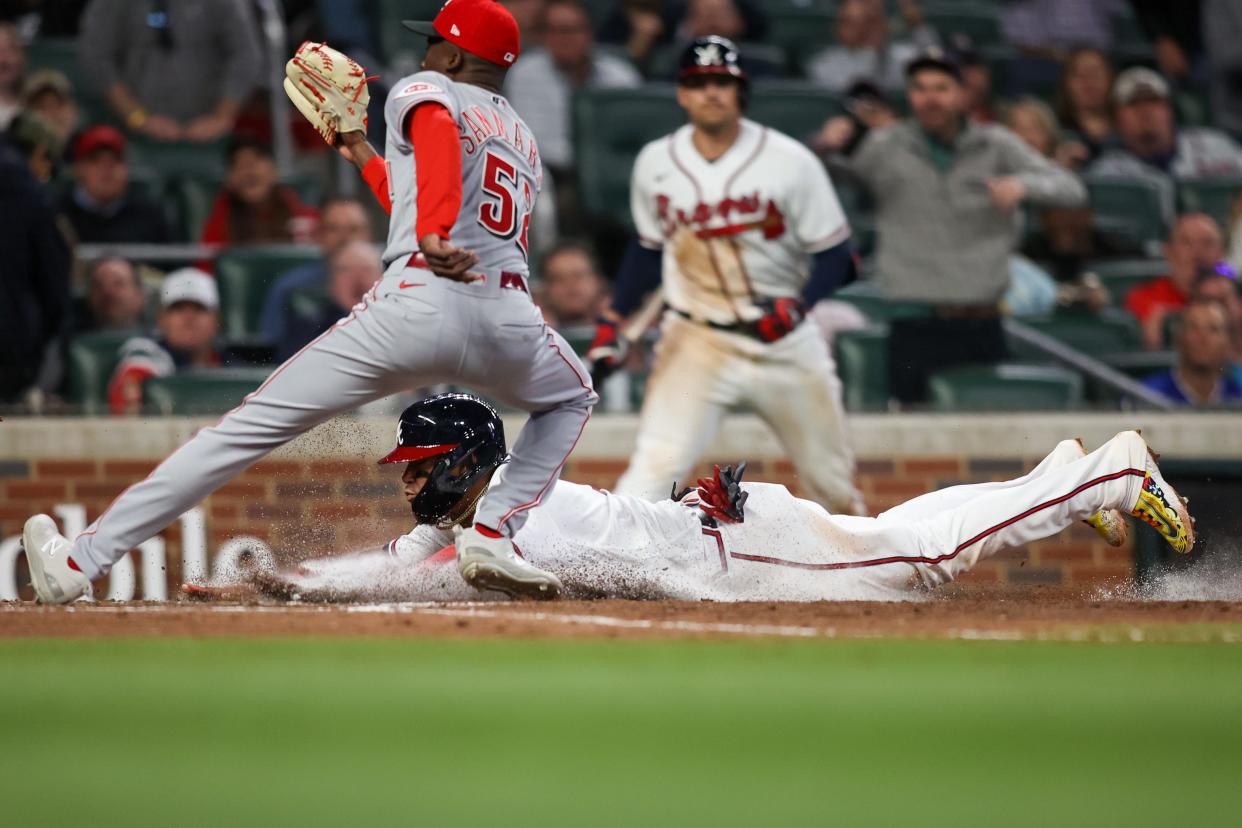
[928,364,1083,411]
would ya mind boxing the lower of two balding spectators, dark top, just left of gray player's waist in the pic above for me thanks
[276,235,384,362]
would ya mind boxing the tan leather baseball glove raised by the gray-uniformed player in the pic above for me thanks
[284,41,375,146]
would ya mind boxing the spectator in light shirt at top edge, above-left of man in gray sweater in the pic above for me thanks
[806,0,936,92]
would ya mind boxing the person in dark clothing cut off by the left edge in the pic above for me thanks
[0,113,70,402]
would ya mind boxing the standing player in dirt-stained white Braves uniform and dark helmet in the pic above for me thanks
[587,36,864,514]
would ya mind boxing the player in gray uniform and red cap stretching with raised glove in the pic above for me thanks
[24,0,597,603]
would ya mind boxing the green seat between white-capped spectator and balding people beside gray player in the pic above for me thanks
[216,245,322,338]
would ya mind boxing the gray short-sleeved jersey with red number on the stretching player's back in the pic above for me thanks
[384,72,543,274]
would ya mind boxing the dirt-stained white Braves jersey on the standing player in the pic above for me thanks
[630,119,850,324]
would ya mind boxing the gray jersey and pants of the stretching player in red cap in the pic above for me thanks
[65,72,599,577]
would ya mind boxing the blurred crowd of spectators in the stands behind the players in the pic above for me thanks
[0,0,1242,413]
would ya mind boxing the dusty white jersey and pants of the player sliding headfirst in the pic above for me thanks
[292,431,1148,601]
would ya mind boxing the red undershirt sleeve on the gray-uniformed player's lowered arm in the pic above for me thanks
[409,103,462,240]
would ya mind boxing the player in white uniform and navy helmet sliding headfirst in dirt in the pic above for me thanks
[186,394,1195,601]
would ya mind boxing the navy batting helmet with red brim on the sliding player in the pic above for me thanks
[380,394,508,525]
